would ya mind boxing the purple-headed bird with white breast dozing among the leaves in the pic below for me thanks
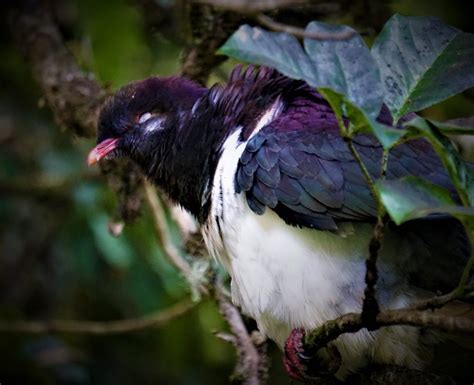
[88,65,472,380]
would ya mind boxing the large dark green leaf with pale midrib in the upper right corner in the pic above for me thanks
[372,15,474,121]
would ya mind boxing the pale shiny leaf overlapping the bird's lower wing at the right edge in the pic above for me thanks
[375,176,474,225]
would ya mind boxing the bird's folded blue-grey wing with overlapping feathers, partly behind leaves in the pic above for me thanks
[236,106,451,230]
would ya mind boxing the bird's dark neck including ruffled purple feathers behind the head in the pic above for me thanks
[144,69,301,223]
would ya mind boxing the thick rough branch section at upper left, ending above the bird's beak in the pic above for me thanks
[9,0,106,138]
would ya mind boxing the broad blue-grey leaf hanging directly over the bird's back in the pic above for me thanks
[220,22,383,117]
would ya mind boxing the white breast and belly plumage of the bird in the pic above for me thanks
[203,104,422,377]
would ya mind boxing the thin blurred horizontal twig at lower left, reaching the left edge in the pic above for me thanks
[0,300,197,335]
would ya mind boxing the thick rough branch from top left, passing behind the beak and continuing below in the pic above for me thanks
[9,0,142,222]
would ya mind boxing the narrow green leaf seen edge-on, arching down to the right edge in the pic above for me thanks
[404,117,474,206]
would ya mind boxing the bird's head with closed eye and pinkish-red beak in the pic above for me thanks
[87,77,205,165]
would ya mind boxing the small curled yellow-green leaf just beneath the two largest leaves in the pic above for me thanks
[318,88,406,150]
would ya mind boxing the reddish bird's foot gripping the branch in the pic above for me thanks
[283,329,341,382]
